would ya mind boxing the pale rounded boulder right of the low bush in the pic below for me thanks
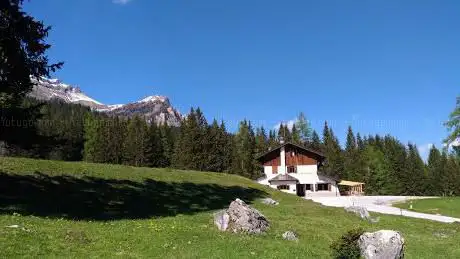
[358,230,404,259]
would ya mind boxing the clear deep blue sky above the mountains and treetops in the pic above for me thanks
[25,0,460,158]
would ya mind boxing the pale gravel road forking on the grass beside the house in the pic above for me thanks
[309,196,460,223]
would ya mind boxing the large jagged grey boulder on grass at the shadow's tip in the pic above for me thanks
[214,199,270,234]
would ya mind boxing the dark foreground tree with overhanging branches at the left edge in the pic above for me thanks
[0,0,63,149]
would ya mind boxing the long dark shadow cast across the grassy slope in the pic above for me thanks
[0,172,266,220]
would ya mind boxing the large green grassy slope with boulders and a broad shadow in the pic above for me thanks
[0,158,460,258]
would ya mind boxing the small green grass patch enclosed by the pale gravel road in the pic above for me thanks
[395,197,460,218]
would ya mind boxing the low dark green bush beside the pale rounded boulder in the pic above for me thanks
[331,228,364,259]
